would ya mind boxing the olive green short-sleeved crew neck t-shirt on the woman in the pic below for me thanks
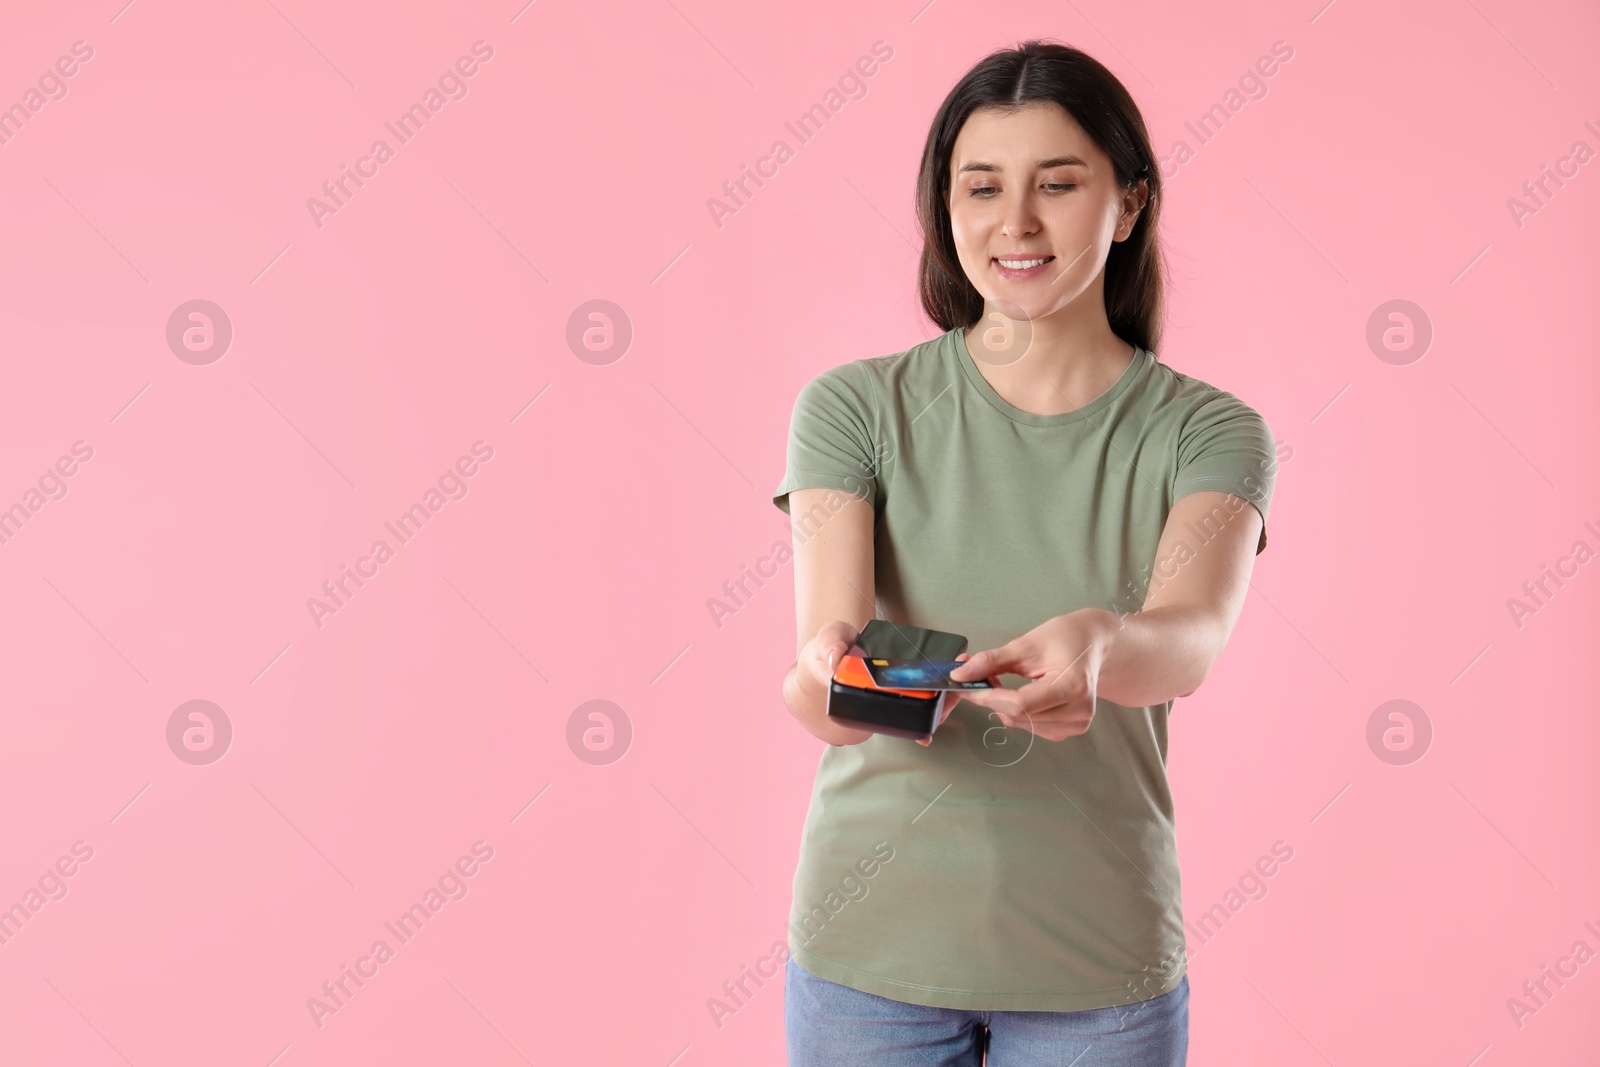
[773,328,1277,1011]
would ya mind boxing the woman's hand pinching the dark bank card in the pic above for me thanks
[950,608,1117,741]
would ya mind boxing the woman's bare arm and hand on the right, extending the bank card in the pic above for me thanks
[950,491,1261,741]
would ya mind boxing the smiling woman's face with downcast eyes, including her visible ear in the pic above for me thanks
[949,102,1147,320]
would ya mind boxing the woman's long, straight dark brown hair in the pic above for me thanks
[917,40,1165,352]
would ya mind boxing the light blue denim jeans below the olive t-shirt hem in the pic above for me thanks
[784,957,1189,1067]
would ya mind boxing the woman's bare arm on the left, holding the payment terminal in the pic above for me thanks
[784,488,877,745]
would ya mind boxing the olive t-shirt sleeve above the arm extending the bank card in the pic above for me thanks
[1173,392,1278,555]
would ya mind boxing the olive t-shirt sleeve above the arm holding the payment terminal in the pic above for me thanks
[773,360,878,514]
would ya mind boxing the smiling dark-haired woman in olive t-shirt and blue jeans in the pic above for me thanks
[773,42,1277,1067]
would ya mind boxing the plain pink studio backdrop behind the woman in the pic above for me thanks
[0,0,1600,1067]
